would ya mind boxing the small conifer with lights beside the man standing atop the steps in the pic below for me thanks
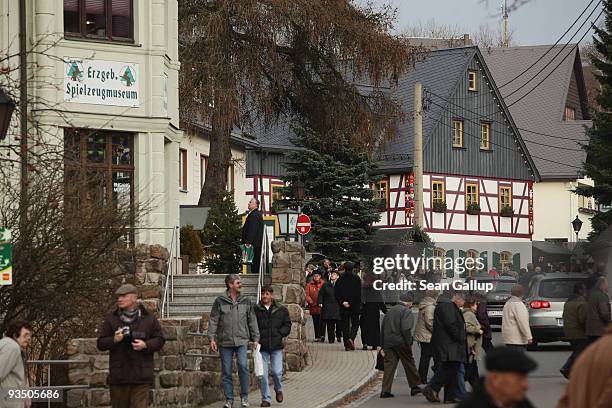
[202,193,242,274]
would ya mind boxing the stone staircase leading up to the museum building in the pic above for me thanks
[168,274,258,319]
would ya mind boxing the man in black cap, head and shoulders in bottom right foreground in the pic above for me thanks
[457,347,538,408]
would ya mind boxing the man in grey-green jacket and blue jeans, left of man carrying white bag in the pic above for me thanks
[208,273,259,408]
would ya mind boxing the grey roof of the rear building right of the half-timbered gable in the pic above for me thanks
[482,45,591,179]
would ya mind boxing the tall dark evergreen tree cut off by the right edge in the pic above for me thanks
[576,0,612,239]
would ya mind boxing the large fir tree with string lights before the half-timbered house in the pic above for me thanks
[283,127,381,261]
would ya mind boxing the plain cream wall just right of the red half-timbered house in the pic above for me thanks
[533,179,593,242]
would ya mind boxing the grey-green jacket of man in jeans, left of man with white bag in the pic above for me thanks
[208,291,259,347]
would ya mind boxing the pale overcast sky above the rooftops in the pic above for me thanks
[375,0,599,45]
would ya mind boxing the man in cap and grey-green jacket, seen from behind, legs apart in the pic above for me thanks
[380,293,421,398]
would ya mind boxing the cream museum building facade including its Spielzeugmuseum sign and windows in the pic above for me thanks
[0,0,182,246]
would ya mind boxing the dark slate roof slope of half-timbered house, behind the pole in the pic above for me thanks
[380,47,476,170]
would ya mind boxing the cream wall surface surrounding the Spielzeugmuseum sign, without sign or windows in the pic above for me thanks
[0,0,182,249]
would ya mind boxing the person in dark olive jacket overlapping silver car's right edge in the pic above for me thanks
[559,282,587,378]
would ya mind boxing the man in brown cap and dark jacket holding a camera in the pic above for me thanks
[98,284,165,408]
